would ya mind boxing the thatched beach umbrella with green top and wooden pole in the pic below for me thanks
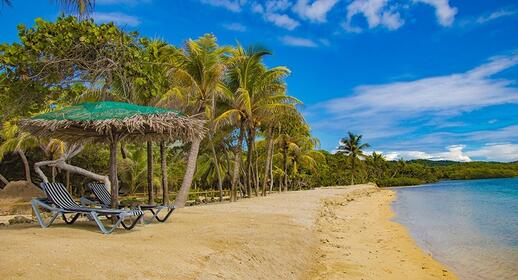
[20,101,205,207]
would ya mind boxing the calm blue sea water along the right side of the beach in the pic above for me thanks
[392,178,518,280]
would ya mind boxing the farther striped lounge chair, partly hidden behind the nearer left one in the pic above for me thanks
[82,183,175,223]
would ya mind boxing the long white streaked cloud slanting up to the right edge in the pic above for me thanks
[320,55,518,119]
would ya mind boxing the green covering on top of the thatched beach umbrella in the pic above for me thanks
[32,101,181,121]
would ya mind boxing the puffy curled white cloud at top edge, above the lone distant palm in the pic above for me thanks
[344,0,404,32]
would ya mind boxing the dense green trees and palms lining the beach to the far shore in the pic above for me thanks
[0,16,518,206]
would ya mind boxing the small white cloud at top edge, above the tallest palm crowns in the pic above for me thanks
[252,0,300,30]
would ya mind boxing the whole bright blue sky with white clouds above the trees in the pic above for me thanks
[0,0,518,161]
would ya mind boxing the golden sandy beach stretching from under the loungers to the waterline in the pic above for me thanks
[0,185,456,280]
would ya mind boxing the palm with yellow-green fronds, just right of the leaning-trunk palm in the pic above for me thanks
[221,45,299,196]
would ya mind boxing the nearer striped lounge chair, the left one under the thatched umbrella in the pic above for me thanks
[31,183,144,234]
